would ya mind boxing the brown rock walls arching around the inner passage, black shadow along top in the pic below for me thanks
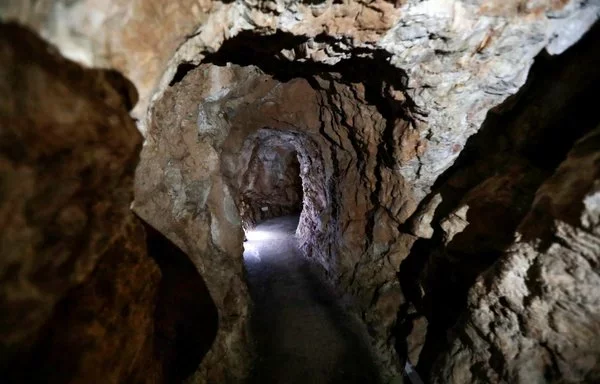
[134,33,422,378]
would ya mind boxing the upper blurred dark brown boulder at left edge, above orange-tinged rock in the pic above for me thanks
[0,25,143,364]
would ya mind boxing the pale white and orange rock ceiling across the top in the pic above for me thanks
[0,0,600,201]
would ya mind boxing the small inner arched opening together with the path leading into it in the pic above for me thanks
[238,128,379,384]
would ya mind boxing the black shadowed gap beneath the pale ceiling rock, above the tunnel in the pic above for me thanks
[202,31,423,130]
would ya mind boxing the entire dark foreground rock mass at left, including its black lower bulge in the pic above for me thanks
[0,24,217,383]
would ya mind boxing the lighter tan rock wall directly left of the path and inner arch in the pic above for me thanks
[134,64,252,383]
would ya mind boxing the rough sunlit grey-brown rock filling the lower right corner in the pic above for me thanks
[433,124,600,383]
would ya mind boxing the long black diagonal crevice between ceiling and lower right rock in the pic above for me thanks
[396,24,600,381]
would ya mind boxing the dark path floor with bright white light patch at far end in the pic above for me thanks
[244,216,379,384]
